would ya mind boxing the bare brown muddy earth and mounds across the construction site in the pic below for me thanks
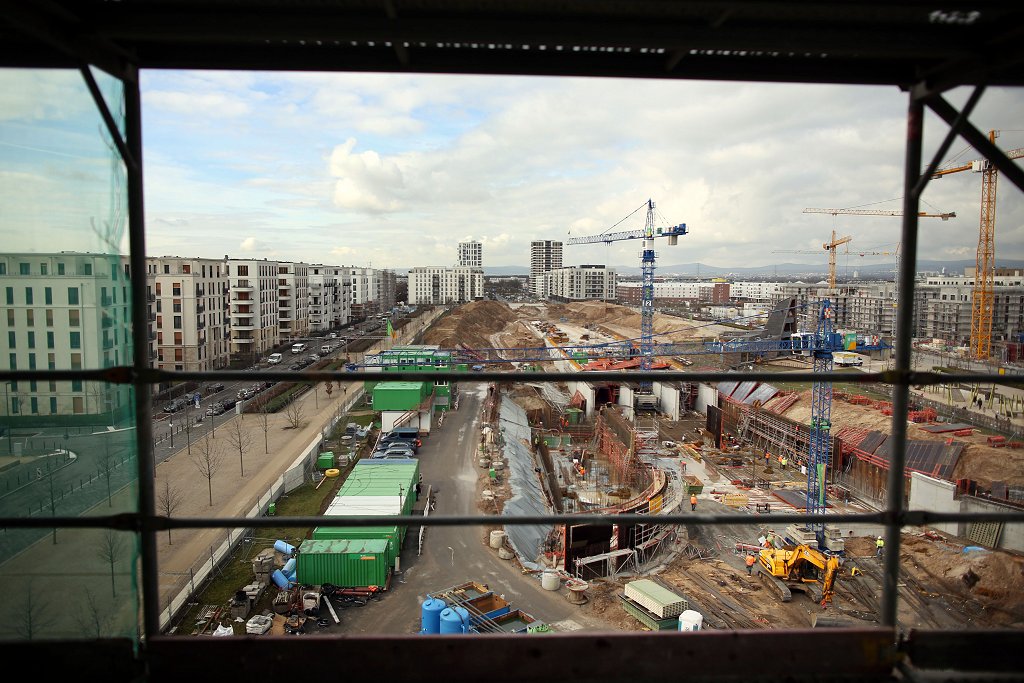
[446,301,1024,631]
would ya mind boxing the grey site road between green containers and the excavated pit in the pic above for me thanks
[325,383,597,635]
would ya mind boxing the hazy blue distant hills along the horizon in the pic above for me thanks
[483,259,1024,280]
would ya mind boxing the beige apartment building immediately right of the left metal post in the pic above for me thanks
[145,256,230,372]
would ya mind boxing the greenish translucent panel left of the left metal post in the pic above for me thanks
[0,70,139,640]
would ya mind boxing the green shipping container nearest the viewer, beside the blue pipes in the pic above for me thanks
[295,539,390,588]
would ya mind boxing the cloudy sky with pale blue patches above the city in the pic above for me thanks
[0,71,1024,270]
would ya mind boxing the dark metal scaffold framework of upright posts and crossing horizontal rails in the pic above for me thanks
[0,40,1024,650]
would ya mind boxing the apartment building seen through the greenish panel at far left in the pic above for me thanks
[0,252,133,421]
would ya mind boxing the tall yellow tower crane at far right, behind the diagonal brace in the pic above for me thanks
[932,130,1024,360]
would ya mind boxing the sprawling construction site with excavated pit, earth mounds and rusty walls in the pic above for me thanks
[424,301,1024,631]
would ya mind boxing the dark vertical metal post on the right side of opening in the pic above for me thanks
[881,94,925,628]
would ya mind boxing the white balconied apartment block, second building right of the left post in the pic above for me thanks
[226,258,281,361]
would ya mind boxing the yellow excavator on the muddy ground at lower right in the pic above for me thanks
[758,545,839,606]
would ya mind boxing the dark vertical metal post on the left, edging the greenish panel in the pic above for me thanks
[123,66,160,639]
